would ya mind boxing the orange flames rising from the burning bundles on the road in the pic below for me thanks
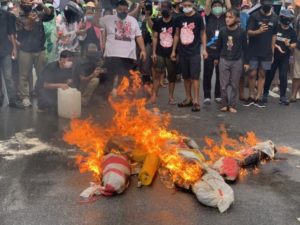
[64,71,258,184]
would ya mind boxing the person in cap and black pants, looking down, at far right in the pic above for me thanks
[263,9,297,105]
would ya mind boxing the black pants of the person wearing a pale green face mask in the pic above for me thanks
[203,55,221,98]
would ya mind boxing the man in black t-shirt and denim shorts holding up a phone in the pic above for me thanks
[244,0,278,108]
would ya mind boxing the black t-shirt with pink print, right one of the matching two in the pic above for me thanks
[175,13,205,56]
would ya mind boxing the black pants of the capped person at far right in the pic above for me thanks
[264,54,290,98]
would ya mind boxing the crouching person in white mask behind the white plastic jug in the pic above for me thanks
[35,50,74,112]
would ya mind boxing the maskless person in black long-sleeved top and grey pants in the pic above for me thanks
[217,8,249,113]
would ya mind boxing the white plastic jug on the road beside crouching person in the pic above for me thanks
[57,88,81,119]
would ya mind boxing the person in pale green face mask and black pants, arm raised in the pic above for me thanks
[203,0,231,105]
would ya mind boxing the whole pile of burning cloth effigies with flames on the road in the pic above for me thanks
[64,71,275,213]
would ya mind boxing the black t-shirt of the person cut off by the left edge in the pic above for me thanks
[0,9,15,57]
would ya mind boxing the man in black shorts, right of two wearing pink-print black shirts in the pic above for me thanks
[171,0,207,112]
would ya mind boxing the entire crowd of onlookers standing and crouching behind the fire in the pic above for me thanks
[0,0,300,113]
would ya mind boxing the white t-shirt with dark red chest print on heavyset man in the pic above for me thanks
[100,15,142,59]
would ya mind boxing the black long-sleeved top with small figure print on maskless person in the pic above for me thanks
[217,27,248,63]
